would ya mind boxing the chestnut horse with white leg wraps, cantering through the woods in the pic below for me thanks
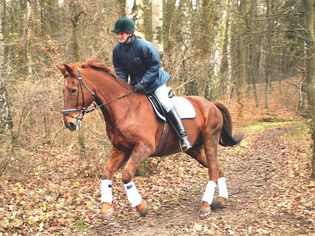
[57,60,243,218]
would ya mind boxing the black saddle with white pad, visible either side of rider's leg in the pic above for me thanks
[147,92,196,122]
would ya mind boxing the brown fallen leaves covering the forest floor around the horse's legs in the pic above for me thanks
[0,123,315,235]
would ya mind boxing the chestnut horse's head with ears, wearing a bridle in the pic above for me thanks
[57,64,95,131]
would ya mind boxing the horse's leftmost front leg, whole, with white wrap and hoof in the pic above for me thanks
[101,147,128,219]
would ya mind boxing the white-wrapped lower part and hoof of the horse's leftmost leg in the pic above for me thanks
[101,179,114,219]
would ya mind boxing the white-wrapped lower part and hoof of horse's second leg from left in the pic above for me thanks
[124,182,148,216]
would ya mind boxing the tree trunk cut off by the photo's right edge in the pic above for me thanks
[303,0,315,178]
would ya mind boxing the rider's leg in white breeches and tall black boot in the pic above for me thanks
[154,84,191,151]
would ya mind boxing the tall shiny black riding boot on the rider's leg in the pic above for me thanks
[167,108,191,151]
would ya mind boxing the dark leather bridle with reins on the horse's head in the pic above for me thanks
[61,67,135,122]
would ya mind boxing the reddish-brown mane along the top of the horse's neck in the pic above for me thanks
[73,59,131,89]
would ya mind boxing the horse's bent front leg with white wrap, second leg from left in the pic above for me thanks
[122,144,152,216]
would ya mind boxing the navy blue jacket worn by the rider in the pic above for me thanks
[113,36,170,94]
